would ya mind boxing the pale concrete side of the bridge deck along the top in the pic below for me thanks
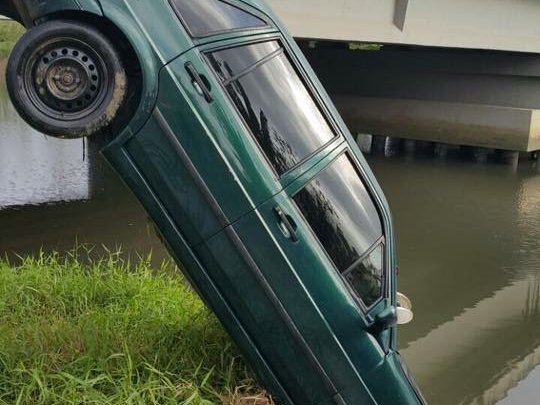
[267,0,540,52]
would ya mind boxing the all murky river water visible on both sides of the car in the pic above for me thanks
[0,58,540,405]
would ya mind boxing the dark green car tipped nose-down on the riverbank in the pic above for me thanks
[0,0,425,405]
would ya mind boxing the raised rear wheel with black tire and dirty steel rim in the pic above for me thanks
[6,20,128,138]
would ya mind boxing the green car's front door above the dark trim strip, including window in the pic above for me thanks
[233,143,398,398]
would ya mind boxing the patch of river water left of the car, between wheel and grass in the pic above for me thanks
[0,61,166,261]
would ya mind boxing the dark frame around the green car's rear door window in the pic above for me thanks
[201,35,343,181]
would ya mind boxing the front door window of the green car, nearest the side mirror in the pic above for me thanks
[293,154,384,307]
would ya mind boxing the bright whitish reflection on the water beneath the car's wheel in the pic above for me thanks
[0,61,90,208]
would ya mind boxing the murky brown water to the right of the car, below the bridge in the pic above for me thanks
[369,149,540,405]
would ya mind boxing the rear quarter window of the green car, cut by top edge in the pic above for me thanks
[171,0,267,37]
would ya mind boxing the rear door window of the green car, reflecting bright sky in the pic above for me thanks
[207,41,336,176]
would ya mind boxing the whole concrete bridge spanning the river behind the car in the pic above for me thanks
[267,0,540,152]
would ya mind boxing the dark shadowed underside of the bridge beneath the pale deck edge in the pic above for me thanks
[301,42,540,152]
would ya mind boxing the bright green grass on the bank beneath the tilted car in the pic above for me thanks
[0,254,270,405]
